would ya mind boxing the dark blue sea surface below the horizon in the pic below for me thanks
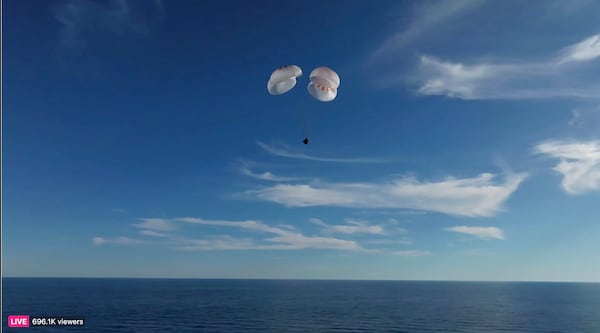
[2,278,600,333]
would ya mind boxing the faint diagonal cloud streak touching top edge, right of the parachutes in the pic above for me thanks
[370,0,486,61]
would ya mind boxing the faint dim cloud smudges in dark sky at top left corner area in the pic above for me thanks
[54,0,164,49]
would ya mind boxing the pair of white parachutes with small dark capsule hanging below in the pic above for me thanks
[267,65,340,145]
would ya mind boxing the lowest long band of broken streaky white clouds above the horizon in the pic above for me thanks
[92,217,428,256]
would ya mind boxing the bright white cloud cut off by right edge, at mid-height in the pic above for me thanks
[534,140,600,195]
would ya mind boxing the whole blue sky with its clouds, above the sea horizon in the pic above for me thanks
[2,0,600,281]
